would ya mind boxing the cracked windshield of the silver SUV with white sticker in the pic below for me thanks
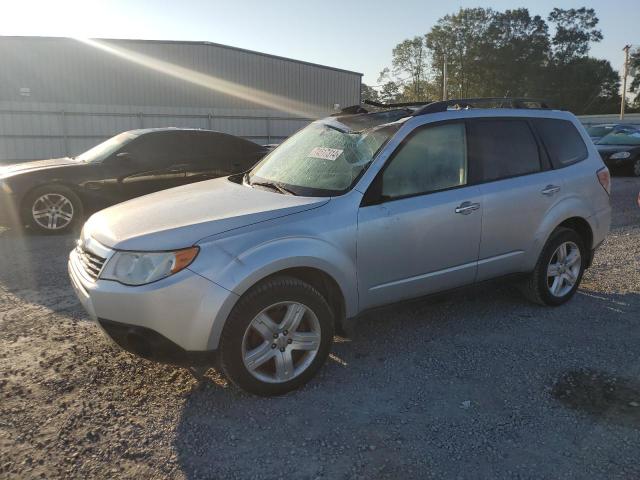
[249,123,399,196]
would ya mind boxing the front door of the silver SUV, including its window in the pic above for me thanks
[357,118,483,309]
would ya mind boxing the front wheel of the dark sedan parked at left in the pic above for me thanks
[22,185,84,234]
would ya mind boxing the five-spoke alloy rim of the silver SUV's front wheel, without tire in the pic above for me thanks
[242,302,321,383]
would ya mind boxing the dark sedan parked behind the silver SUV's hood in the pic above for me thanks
[0,128,268,233]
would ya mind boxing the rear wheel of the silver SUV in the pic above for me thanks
[522,228,587,306]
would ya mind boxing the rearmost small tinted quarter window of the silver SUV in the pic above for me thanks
[533,118,588,168]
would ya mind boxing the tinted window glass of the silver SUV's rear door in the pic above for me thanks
[468,119,540,182]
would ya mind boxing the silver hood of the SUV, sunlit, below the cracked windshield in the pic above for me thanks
[83,178,329,251]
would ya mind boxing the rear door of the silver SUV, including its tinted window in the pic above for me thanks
[467,118,562,281]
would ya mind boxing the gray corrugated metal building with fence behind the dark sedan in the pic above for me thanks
[0,36,362,162]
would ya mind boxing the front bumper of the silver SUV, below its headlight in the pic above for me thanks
[68,250,237,360]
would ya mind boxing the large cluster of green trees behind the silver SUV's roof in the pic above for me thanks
[379,7,620,113]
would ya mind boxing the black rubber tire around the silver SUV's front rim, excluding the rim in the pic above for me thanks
[220,276,334,396]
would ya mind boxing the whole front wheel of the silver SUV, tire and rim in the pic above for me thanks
[219,276,334,396]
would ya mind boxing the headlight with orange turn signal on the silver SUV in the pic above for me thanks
[100,247,200,285]
